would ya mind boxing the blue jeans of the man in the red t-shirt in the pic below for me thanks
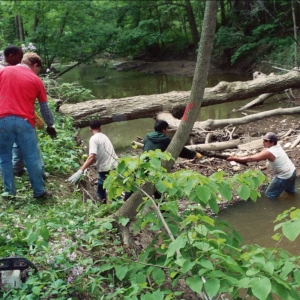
[0,116,45,197]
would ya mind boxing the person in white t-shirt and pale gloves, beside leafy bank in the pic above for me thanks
[67,120,118,204]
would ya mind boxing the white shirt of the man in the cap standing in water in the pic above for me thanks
[267,144,296,179]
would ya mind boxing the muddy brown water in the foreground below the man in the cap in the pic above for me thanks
[218,179,300,255]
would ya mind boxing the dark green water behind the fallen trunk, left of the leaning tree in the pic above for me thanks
[59,65,192,99]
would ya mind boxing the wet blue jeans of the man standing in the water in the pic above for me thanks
[266,170,297,199]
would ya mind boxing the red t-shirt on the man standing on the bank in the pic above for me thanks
[0,66,47,127]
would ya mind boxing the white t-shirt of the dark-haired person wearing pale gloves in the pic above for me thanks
[89,132,118,172]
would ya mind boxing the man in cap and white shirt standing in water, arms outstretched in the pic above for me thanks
[227,132,297,200]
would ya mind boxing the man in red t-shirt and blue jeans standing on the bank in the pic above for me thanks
[0,53,56,198]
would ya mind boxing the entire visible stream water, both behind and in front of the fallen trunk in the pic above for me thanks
[59,64,300,255]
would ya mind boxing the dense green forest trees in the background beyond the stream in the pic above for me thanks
[0,0,300,67]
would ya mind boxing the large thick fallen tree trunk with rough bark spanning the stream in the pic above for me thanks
[59,71,300,127]
